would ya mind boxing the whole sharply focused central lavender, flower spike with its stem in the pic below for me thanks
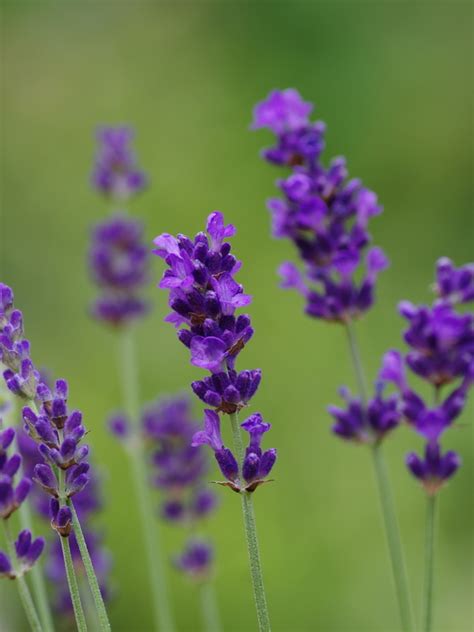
[154,212,276,631]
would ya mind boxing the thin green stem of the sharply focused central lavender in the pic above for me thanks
[229,413,271,632]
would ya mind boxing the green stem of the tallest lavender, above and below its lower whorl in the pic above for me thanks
[346,322,414,632]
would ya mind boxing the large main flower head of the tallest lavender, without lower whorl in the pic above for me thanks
[252,89,388,323]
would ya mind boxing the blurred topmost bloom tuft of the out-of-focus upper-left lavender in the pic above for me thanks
[92,127,146,201]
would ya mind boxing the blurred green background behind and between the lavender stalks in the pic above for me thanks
[0,0,473,632]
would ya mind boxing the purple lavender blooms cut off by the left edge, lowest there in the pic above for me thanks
[0,419,44,579]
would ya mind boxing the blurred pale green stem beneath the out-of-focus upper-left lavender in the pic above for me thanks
[119,328,174,632]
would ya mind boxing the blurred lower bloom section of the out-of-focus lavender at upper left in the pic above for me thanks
[89,214,149,327]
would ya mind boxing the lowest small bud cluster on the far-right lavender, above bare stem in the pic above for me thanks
[406,443,461,496]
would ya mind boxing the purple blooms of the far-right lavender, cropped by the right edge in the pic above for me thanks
[380,258,474,494]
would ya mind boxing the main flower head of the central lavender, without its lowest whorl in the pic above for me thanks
[154,211,260,414]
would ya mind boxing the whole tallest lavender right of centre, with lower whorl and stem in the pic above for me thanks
[252,89,413,631]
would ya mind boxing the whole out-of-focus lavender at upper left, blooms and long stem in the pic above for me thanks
[89,127,173,632]
